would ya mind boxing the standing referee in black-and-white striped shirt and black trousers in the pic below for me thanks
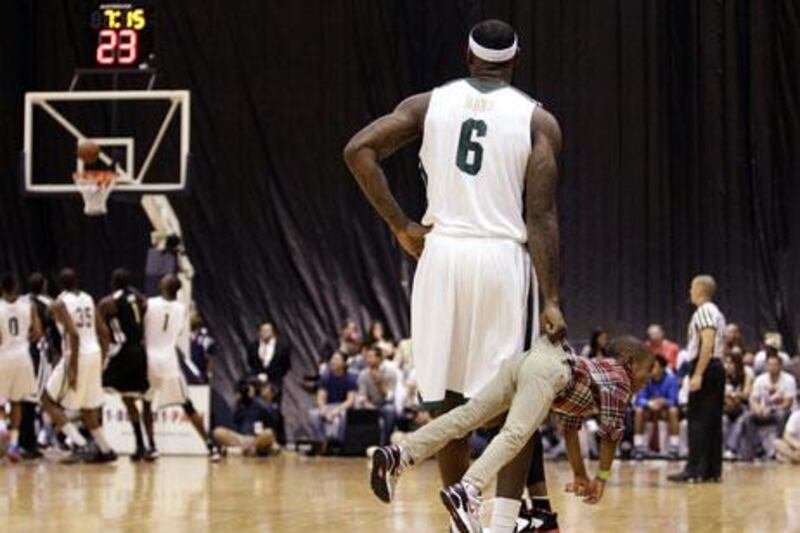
[667,276,725,483]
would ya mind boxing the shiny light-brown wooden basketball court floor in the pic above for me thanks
[0,453,800,533]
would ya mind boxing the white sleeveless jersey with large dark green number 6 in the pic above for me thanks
[419,79,539,243]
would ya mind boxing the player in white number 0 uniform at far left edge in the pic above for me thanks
[0,275,42,462]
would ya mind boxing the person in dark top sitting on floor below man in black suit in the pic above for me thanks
[213,380,283,457]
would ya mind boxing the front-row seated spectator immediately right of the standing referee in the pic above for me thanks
[722,346,755,460]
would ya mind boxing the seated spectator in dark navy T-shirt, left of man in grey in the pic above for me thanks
[309,352,358,453]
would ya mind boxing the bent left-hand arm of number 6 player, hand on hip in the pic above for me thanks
[344,93,430,258]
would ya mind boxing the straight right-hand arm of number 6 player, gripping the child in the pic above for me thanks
[525,108,567,341]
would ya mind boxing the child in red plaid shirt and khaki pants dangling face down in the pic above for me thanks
[371,337,653,533]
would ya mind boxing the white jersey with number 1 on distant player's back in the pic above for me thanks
[144,296,186,379]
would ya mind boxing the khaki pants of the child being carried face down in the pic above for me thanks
[402,337,571,490]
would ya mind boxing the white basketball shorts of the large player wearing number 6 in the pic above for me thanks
[411,234,539,407]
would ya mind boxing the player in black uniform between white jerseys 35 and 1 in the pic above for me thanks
[97,268,150,461]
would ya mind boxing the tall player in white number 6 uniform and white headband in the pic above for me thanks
[344,20,566,532]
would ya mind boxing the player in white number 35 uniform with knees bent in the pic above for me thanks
[42,268,117,463]
